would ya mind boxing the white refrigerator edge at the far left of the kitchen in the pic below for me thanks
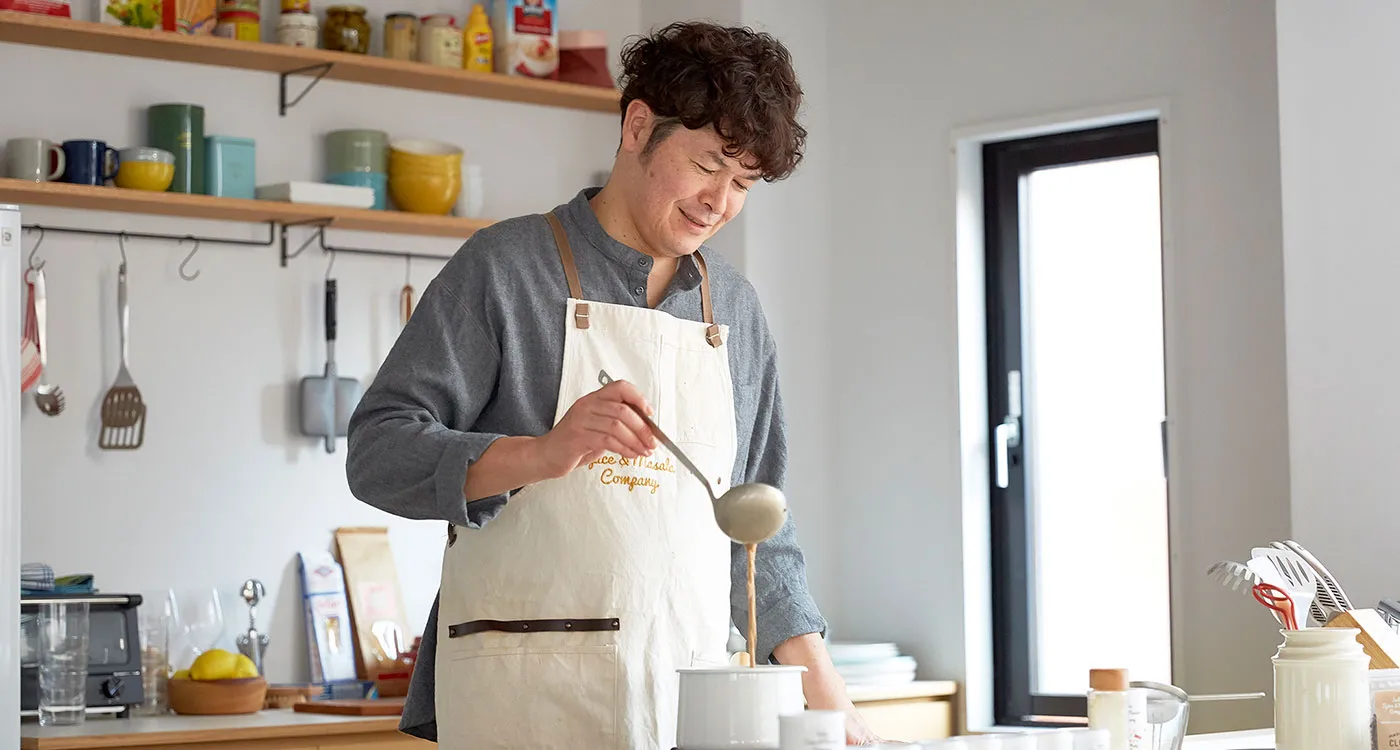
[0,203,24,747]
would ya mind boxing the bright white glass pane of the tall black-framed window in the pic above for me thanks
[1021,155,1172,695]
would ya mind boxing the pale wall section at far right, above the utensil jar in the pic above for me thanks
[1278,0,1400,621]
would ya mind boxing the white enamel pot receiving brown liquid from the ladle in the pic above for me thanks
[676,665,806,750]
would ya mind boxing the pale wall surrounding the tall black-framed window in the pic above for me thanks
[827,0,1288,729]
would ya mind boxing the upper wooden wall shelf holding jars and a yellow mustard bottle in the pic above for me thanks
[0,10,620,113]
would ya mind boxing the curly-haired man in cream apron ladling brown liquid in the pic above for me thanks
[347,22,875,750]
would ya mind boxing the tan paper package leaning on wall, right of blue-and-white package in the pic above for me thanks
[336,526,412,680]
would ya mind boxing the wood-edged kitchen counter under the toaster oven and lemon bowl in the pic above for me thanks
[20,709,434,750]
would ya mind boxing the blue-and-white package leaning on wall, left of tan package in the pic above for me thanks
[298,551,356,683]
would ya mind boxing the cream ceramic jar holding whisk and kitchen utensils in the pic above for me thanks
[1274,628,1371,750]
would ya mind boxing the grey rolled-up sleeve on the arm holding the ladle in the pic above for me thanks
[346,263,507,528]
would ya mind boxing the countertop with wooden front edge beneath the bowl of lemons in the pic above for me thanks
[20,708,399,750]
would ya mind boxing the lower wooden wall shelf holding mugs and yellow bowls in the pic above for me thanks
[0,178,491,239]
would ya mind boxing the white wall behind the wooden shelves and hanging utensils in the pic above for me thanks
[0,0,638,681]
